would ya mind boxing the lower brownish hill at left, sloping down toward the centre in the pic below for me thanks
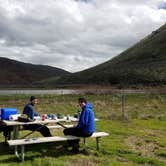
[0,57,69,87]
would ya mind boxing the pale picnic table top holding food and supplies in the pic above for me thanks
[2,117,78,126]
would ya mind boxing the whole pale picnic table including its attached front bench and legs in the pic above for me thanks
[2,117,109,161]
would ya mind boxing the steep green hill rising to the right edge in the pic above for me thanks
[57,24,166,87]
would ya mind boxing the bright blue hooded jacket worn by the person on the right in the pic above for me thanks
[77,103,95,134]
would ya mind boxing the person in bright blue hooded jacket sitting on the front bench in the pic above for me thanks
[63,98,95,152]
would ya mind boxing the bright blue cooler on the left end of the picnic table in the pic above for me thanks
[1,108,17,120]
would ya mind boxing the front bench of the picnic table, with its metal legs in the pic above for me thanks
[8,132,109,161]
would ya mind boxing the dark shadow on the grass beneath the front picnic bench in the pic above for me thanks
[0,142,111,163]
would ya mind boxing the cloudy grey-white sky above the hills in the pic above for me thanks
[0,0,166,72]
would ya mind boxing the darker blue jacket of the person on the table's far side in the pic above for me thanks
[23,103,39,120]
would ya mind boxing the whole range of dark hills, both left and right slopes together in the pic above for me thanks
[0,24,166,88]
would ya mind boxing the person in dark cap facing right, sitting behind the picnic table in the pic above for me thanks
[23,96,52,137]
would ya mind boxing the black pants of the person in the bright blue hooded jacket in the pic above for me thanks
[63,127,92,147]
